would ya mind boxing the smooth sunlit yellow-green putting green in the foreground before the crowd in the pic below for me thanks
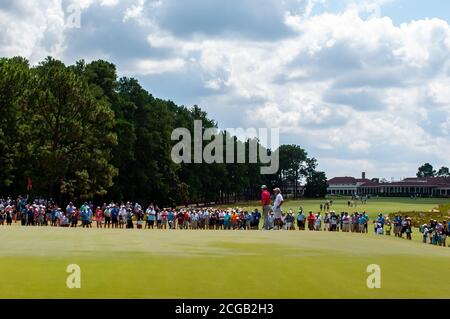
[0,226,450,298]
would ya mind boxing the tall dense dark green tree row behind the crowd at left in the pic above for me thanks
[0,58,326,205]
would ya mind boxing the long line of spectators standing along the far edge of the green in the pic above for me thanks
[0,197,450,247]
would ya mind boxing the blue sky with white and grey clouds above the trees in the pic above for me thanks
[0,0,450,179]
